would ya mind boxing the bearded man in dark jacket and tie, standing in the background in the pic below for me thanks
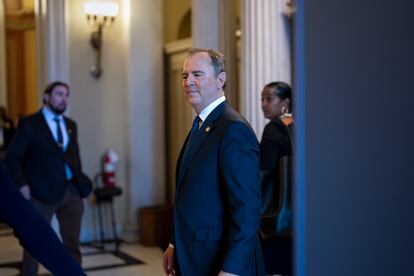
[5,82,92,275]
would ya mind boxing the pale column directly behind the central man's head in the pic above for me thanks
[192,0,238,108]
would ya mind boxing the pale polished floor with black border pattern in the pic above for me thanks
[0,227,164,276]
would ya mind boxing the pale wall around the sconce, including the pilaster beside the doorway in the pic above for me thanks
[67,0,166,240]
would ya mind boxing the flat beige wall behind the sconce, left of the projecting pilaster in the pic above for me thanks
[67,0,129,239]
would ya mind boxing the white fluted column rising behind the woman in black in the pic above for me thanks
[240,0,291,138]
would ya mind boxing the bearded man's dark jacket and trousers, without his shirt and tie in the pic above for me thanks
[5,110,92,270]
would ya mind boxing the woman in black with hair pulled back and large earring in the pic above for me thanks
[260,82,293,275]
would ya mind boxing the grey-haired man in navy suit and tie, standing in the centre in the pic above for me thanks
[163,49,264,276]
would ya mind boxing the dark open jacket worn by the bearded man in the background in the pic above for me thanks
[5,110,92,204]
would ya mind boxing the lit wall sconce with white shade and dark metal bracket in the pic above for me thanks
[84,0,119,79]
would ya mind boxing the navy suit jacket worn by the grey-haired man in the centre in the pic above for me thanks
[173,103,264,275]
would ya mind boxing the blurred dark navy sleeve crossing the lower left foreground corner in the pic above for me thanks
[0,164,85,276]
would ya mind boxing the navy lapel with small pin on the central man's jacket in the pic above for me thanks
[175,102,227,195]
